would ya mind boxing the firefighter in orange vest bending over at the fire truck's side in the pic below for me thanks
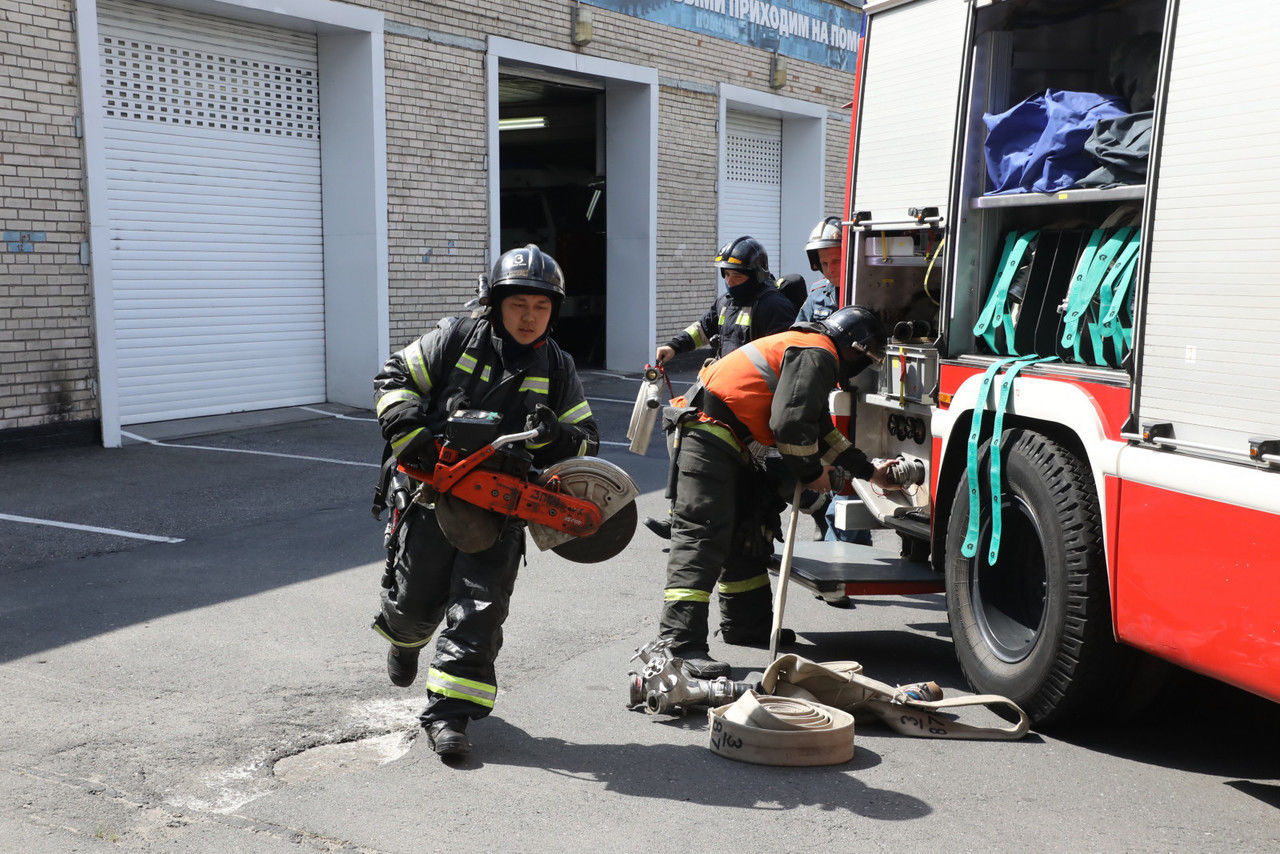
[659,306,895,679]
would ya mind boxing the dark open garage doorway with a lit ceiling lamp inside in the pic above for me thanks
[498,69,607,367]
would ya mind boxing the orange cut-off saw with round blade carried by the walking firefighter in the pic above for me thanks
[399,411,640,563]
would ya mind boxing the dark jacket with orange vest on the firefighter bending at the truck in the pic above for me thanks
[699,329,874,483]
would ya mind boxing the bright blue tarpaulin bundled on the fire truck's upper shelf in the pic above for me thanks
[982,88,1129,196]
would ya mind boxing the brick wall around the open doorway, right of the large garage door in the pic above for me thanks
[365,0,854,346]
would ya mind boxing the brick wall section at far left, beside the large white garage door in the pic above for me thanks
[0,0,97,428]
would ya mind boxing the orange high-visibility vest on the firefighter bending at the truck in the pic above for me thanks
[698,329,840,447]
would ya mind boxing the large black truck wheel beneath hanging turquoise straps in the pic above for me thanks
[946,428,1128,727]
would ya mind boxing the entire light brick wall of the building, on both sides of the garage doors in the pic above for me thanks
[0,0,852,430]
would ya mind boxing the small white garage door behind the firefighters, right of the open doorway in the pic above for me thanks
[721,113,782,268]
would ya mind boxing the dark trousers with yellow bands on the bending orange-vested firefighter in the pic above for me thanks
[659,424,777,654]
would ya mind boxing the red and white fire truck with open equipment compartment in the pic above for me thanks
[792,0,1280,726]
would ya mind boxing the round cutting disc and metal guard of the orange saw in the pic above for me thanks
[529,457,640,563]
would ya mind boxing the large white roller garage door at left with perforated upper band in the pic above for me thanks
[99,0,325,424]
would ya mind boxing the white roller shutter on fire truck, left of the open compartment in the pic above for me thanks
[852,0,969,220]
